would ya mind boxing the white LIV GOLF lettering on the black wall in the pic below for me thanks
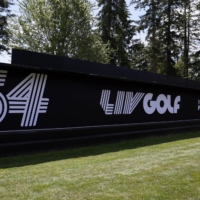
[100,90,181,115]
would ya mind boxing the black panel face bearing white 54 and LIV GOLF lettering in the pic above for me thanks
[0,61,200,132]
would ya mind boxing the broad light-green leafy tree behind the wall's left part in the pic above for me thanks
[10,0,110,63]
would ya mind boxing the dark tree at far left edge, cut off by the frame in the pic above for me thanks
[0,0,14,54]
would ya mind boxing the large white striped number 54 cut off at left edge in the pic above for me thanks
[0,70,49,127]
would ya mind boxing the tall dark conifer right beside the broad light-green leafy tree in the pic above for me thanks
[98,0,135,67]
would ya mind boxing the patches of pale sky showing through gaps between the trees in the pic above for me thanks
[0,0,145,63]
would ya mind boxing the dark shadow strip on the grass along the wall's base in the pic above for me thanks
[0,132,200,169]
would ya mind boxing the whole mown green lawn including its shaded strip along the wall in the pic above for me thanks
[0,132,200,200]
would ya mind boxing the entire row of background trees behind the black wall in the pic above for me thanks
[0,0,200,80]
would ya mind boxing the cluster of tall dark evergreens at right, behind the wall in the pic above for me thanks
[132,0,200,78]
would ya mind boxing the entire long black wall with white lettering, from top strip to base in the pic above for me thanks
[0,49,200,153]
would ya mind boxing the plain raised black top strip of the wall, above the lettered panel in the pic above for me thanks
[11,49,200,90]
